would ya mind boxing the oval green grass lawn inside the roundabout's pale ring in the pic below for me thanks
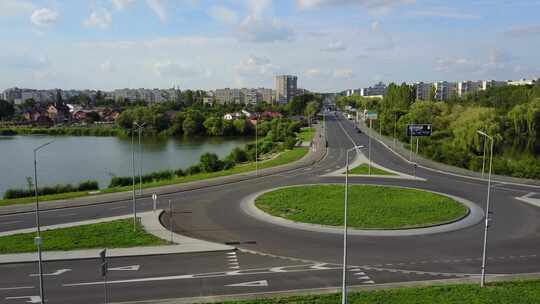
[255,185,468,229]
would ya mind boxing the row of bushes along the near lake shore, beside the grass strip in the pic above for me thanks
[109,119,301,188]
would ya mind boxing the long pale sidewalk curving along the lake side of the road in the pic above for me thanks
[0,125,326,215]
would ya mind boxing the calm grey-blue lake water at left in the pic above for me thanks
[0,136,250,198]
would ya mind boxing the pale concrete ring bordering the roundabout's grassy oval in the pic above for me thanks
[240,184,485,237]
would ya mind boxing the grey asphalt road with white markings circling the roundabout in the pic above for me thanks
[0,115,540,303]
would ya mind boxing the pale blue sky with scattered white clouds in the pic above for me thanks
[0,0,540,92]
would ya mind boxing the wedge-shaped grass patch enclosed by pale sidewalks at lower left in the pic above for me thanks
[0,219,168,254]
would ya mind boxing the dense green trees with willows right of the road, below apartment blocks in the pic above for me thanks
[338,84,540,179]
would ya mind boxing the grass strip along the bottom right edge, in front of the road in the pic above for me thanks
[208,280,540,304]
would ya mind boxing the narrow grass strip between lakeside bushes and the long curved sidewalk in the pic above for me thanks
[0,148,309,206]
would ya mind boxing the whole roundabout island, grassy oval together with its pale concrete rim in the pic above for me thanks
[242,184,484,236]
